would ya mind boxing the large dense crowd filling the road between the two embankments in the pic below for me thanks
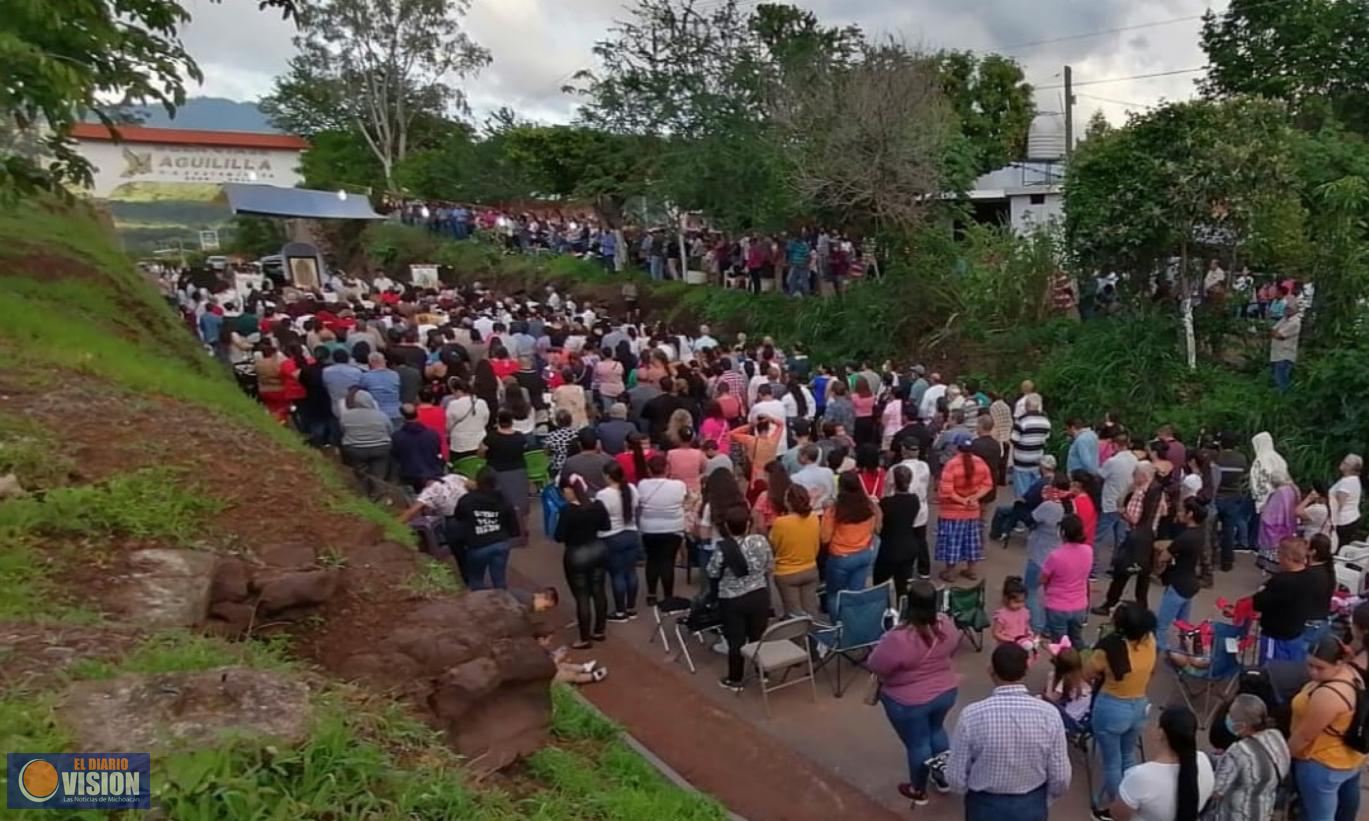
[162,264,1369,821]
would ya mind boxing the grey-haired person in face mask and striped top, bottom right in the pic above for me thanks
[1205,692,1292,821]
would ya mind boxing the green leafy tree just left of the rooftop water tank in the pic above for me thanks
[935,51,1036,174]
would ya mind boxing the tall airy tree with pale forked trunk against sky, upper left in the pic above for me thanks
[275,0,490,186]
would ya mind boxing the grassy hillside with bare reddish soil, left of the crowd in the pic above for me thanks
[0,204,723,821]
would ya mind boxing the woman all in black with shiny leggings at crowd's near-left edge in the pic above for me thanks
[556,471,609,650]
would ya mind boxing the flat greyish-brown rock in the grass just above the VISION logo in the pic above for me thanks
[57,668,311,751]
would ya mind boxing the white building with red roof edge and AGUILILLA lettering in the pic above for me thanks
[71,123,309,198]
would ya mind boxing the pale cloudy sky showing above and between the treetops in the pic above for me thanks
[183,0,1225,130]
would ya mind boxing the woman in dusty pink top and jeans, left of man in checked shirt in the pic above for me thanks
[865,580,960,805]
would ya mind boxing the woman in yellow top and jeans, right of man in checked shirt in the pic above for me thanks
[1088,602,1155,818]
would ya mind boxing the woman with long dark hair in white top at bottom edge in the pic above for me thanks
[1112,706,1214,821]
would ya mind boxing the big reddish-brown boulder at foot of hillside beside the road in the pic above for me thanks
[341,590,556,772]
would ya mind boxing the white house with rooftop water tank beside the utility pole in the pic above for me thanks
[969,114,1065,233]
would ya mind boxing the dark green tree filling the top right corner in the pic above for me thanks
[1201,0,1369,133]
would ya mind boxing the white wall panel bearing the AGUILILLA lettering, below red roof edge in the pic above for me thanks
[78,140,303,197]
